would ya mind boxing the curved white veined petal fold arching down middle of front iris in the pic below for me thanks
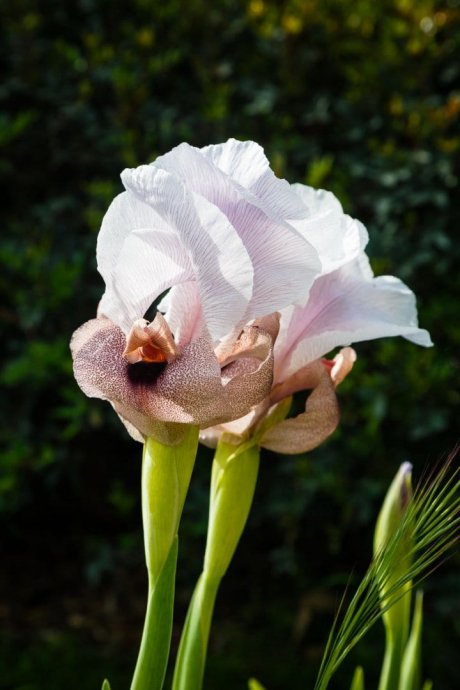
[122,165,253,340]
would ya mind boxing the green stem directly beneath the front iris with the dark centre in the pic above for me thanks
[131,426,198,690]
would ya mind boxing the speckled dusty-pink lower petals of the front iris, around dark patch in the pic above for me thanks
[71,319,273,438]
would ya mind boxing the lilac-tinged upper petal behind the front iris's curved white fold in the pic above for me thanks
[153,144,320,322]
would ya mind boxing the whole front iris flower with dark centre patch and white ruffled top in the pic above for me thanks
[71,139,343,443]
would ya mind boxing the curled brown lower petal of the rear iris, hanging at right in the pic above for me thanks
[260,361,340,455]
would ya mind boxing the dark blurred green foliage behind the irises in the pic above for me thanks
[0,0,460,690]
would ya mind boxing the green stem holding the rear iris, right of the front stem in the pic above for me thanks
[173,442,259,690]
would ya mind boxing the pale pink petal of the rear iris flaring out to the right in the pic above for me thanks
[275,258,431,381]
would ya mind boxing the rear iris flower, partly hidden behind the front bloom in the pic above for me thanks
[201,185,432,453]
